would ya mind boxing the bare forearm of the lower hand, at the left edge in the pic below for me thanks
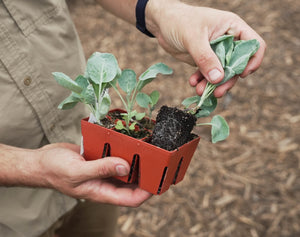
[0,144,45,187]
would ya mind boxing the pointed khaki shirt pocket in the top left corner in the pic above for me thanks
[2,0,64,36]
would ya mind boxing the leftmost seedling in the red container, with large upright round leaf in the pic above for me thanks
[52,52,121,124]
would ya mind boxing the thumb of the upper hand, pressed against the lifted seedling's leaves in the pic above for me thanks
[189,39,224,84]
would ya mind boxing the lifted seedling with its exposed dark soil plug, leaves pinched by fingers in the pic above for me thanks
[152,35,259,150]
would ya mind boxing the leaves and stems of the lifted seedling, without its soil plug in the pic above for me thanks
[182,35,259,143]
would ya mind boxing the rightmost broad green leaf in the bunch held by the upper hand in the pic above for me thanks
[228,39,259,74]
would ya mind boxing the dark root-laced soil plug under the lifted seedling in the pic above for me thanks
[151,106,197,151]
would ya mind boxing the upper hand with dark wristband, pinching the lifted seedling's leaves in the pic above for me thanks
[146,0,266,97]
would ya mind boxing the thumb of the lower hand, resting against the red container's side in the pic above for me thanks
[78,157,130,180]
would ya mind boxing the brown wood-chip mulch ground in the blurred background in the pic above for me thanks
[69,0,300,237]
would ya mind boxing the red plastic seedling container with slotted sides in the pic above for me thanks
[81,110,200,195]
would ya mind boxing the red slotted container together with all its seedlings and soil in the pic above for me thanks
[53,36,258,194]
